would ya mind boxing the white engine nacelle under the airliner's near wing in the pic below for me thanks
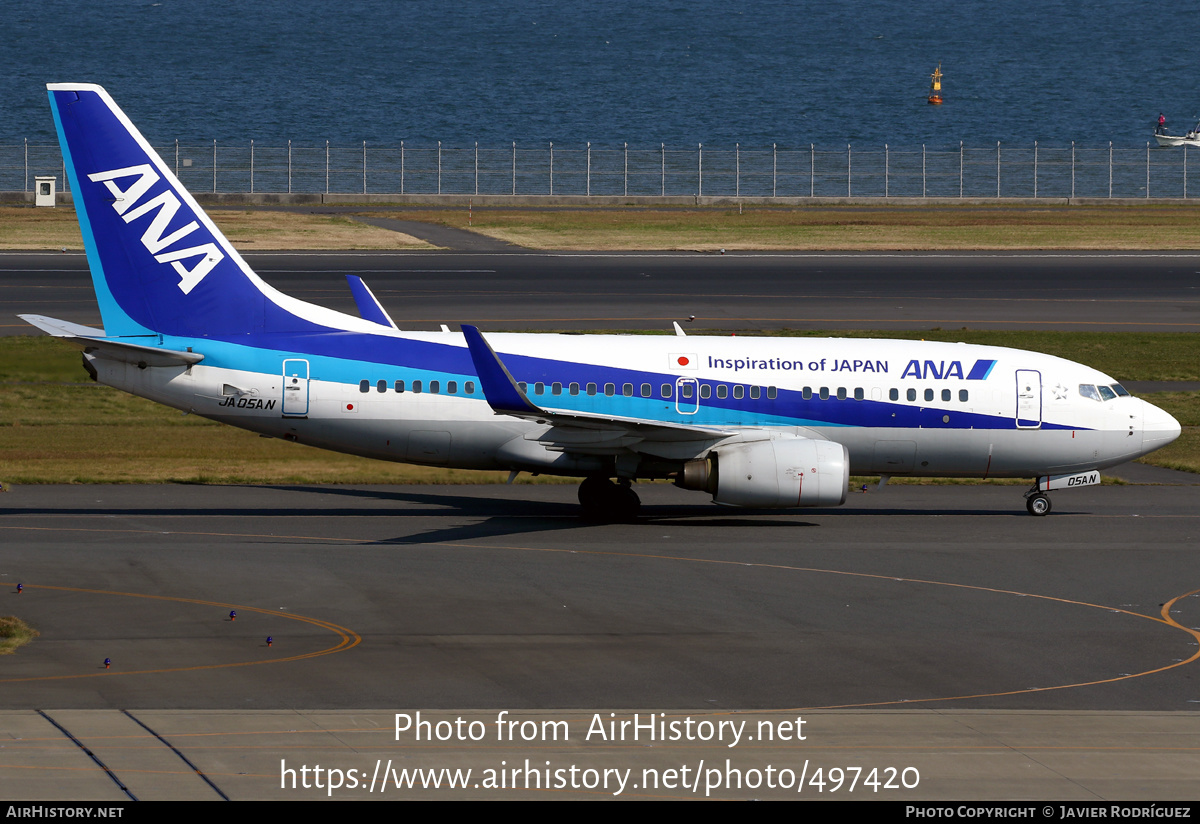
[676,438,850,509]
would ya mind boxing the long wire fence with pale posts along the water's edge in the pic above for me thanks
[0,140,1200,199]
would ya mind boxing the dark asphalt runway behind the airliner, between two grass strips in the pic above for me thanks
[0,251,1200,335]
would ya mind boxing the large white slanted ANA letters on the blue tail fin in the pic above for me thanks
[88,163,224,295]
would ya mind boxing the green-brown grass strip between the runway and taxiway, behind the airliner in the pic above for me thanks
[0,330,1200,483]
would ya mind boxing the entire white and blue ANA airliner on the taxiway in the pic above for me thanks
[22,84,1180,518]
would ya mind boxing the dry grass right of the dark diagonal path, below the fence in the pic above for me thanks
[352,204,1200,251]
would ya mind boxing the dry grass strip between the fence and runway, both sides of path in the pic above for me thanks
[11,202,1200,251]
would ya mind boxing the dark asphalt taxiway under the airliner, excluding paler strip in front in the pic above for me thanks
[0,485,1200,711]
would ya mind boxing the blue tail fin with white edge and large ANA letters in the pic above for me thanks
[47,83,378,337]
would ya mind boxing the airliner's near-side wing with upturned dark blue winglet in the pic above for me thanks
[462,324,734,451]
